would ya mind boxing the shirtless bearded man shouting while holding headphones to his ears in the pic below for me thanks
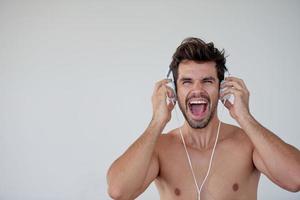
[107,38,300,200]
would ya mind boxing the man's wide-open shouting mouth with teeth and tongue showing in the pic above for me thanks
[188,99,209,119]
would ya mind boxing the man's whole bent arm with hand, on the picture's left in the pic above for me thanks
[107,80,174,199]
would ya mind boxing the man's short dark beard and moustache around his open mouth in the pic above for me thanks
[178,95,218,129]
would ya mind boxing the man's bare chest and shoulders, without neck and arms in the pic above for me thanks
[155,123,260,200]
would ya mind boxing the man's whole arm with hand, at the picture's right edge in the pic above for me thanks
[221,77,300,192]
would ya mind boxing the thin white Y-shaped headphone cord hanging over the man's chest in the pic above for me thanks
[175,106,224,200]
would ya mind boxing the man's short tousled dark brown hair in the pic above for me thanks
[169,37,228,90]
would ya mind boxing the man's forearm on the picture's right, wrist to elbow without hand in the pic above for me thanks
[239,115,300,188]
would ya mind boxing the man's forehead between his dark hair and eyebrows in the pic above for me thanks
[178,60,218,78]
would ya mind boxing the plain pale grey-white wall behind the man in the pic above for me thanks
[0,0,300,200]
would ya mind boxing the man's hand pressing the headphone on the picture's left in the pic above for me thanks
[152,79,175,124]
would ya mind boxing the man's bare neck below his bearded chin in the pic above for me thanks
[182,115,220,150]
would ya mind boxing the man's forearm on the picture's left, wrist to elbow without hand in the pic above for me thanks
[107,120,165,198]
